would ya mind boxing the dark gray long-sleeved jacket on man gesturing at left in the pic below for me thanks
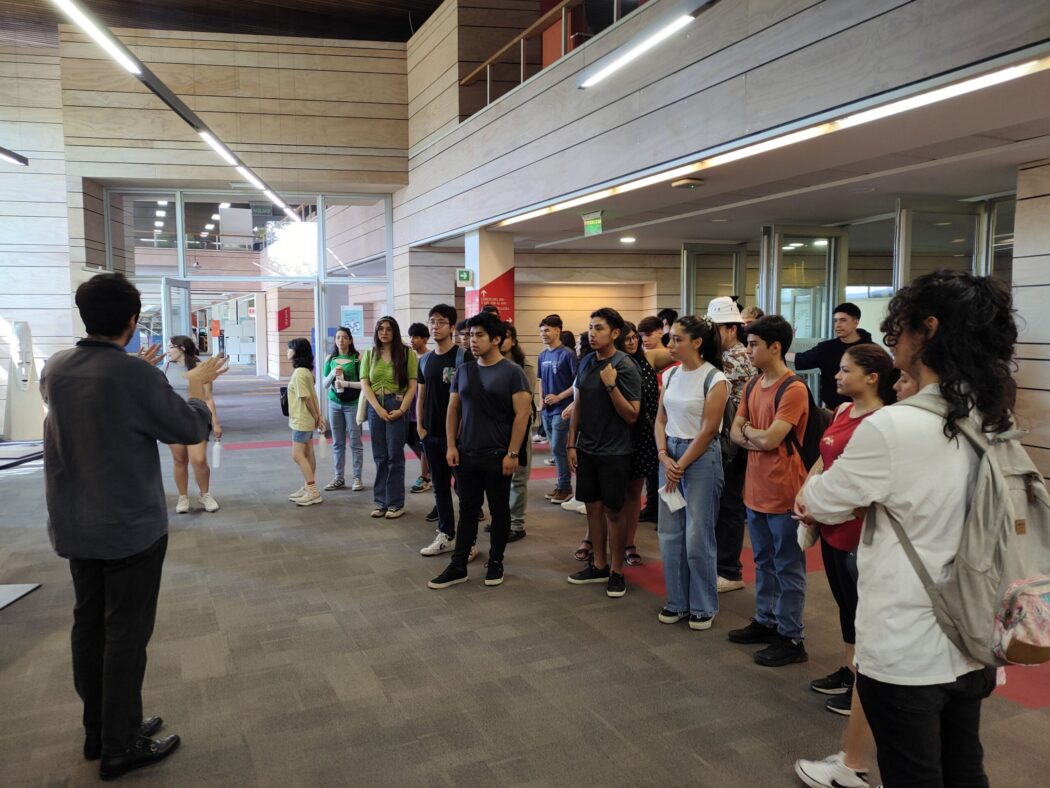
[40,339,211,559]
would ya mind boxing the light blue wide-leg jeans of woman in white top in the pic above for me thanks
[657,437,722,618]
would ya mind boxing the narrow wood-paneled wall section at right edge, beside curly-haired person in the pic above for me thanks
[1013,161,1050,476]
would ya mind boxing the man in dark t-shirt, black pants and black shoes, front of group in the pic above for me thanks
[427,313,532,588]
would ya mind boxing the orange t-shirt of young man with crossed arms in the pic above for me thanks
[736,370,810,515]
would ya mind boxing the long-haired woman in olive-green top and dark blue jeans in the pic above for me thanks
[361,316,418,520]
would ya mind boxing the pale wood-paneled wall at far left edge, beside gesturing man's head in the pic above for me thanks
[0,47,71,433]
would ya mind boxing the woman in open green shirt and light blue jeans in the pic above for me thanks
[323,326,364,492]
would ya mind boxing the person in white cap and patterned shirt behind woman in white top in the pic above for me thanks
[708,295,755,594]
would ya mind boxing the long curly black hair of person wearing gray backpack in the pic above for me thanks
[880,269,1017,438]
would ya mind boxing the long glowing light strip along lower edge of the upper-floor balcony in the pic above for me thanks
[496,53,1050,227]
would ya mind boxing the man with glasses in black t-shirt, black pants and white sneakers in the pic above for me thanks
[416,304,473,556]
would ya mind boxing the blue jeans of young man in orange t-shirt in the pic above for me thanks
[748,509,805,640]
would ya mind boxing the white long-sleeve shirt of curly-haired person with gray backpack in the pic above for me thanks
[802,383,981,685]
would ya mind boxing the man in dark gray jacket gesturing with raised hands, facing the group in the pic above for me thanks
[40,273,226,780]
